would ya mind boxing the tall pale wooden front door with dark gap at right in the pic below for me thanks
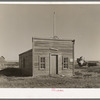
[50,55,58,75]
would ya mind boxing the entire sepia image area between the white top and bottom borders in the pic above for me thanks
[0,4,100,91]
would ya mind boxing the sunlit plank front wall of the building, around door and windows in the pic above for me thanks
[33,39,73,76]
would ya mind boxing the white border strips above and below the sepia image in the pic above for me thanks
[0,1,100,99]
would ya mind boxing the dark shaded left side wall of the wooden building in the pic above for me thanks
[19,50,32,76]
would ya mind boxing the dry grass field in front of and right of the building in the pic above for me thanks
[0,66,100,88]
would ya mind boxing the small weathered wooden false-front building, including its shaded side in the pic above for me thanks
[19,38,75,76]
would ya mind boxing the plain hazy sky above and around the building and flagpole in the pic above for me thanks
[0,4,100,60]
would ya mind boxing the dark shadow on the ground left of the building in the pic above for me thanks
[0,68,26,77]
